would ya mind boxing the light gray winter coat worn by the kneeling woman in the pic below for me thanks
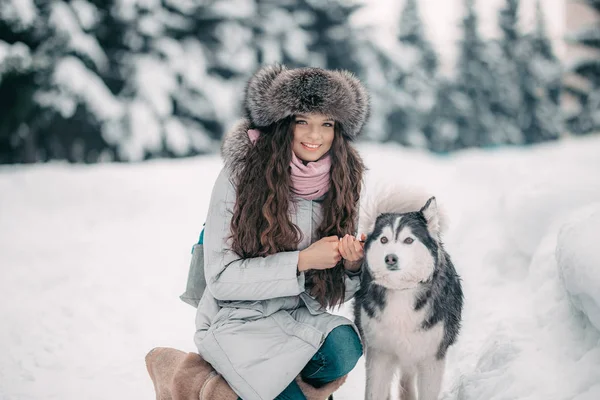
[182,121,360,400]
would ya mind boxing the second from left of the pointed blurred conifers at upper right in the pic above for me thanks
[456,0,496,148]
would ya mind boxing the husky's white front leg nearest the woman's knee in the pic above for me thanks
[365,348,396,400]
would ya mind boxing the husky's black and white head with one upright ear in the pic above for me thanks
[365,197,440,289]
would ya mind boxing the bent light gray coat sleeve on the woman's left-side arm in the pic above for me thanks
[204,168,304,301]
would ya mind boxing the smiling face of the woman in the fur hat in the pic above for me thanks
[292,114,334,162]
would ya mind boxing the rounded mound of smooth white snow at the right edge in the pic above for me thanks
[556,203,600,330]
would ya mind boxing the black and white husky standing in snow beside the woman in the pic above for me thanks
[354,191,463,400]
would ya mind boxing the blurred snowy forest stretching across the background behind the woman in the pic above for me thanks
[0,0,600,163]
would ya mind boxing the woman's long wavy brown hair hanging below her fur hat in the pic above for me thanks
[231,116,364,307]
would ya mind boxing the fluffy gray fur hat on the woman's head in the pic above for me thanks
[244,64,369,139]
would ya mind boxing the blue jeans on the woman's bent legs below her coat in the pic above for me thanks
[237,325,363,400]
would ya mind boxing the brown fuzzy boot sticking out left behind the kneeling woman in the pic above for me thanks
[146,347,238,400]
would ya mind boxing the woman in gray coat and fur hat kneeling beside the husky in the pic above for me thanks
[149,66,368,400]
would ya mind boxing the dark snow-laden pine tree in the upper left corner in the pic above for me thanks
[0,1,116,162]
